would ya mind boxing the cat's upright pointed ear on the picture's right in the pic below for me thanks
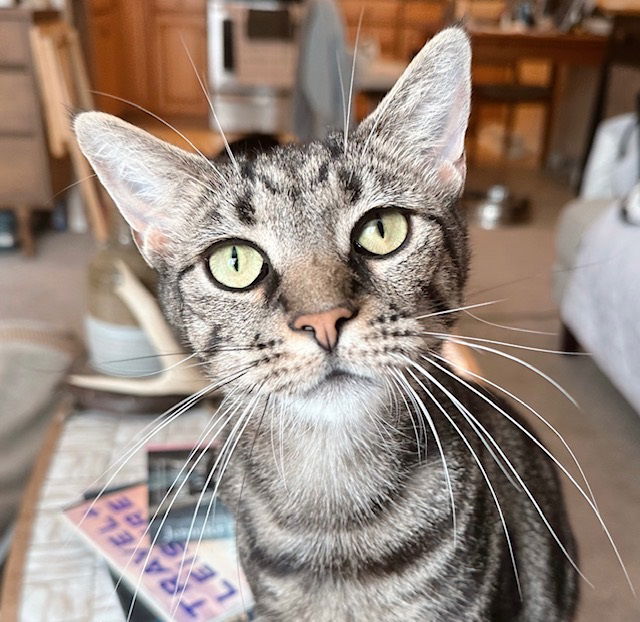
[361,28,471,191]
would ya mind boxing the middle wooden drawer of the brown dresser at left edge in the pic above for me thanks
[0,72,39,135]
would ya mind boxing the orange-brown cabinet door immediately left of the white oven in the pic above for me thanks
[151,13,208,116]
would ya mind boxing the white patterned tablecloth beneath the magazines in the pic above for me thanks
[17,408,210,622]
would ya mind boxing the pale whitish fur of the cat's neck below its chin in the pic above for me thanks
[228,388,432,520]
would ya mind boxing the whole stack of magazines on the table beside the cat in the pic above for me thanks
[65,447,253,622]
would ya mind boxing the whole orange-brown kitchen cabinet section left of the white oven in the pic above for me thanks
[75,0,208,119]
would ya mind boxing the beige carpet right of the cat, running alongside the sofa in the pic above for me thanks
[457,171,640,622]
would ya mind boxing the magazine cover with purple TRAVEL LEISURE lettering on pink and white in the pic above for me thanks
[64,484,253,622]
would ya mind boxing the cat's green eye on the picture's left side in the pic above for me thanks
[209,242,267,289]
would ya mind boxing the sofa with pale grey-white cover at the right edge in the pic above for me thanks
[553,115,640,413]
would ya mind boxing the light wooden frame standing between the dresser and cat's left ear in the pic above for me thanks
[31,15,111,242]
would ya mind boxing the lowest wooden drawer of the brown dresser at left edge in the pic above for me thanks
[0,136,52,205]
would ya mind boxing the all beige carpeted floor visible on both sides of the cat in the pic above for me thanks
[0,165,640,622]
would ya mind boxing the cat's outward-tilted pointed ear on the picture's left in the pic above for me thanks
[74,112,208,267]
